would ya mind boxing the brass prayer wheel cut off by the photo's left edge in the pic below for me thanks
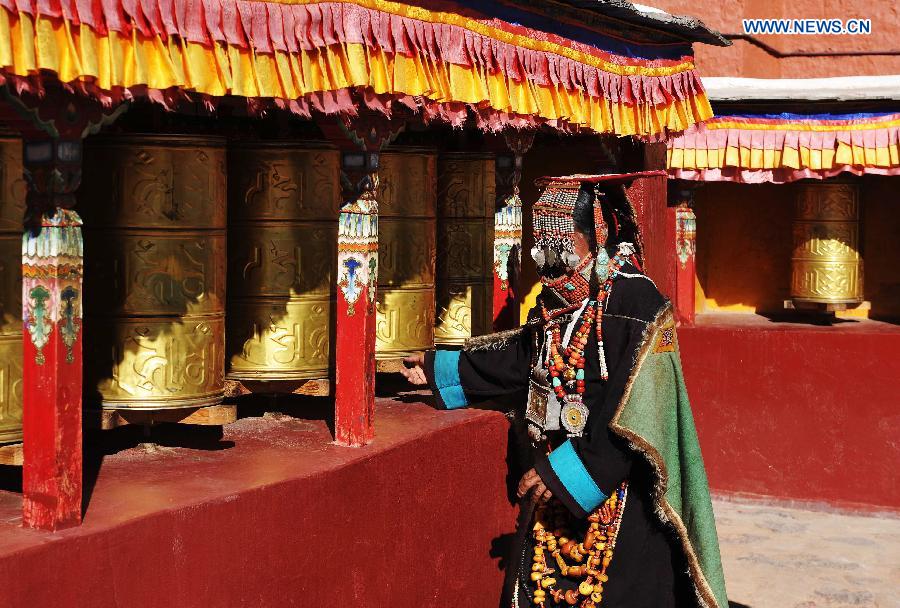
[0,137,27,444]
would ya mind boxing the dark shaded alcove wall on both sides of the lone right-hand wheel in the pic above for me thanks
[695,176,900,322]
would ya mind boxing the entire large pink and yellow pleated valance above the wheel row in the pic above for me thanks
[0,0,712,136]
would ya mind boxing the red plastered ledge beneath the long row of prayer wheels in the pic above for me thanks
[0,399,515,608]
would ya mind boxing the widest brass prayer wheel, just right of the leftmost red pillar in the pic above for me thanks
[79,135,226,410]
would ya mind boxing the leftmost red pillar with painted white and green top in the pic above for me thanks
[22,137,82,530]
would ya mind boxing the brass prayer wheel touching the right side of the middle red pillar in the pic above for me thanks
[375,149,437,360]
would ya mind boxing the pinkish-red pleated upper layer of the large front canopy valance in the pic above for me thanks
[0,0,703,106]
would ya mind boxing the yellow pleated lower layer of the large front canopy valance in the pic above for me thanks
[0,9,712,135]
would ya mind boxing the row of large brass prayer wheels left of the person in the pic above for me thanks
[0,135,495,422]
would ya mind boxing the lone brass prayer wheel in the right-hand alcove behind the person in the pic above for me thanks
[791,182,863,309]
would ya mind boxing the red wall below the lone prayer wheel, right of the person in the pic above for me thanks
[679,322,900,509]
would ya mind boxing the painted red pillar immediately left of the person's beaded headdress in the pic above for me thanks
[493,130,534,331]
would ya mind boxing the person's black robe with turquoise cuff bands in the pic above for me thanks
[425,265,697,608]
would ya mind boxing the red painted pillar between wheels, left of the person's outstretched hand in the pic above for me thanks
[319,111,406,446]
